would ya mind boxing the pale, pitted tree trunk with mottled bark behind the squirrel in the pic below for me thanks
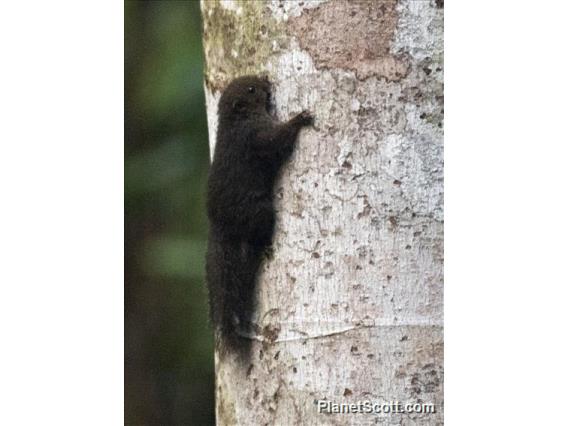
[202,0,443,425]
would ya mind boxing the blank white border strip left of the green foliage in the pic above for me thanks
[0,1,124,426]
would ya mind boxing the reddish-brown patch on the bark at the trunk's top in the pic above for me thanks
[287,0,409,81]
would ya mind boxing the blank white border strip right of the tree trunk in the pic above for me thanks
[445,1,568,426]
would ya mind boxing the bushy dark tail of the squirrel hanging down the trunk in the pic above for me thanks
[206,231,262,356]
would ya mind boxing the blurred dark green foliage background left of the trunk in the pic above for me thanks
[124,0,214,425]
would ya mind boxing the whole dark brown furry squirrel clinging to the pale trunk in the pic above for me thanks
[206,76,313,352]
